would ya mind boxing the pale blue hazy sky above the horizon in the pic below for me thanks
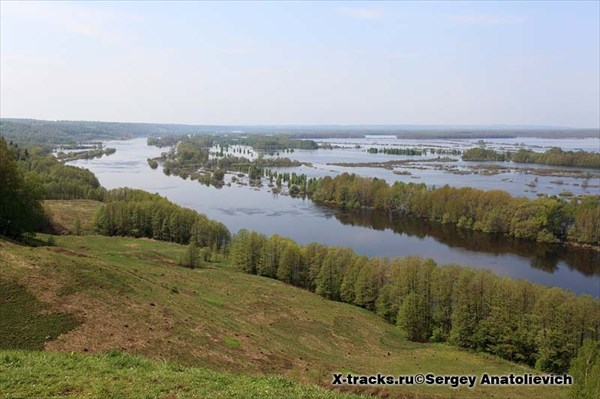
[0,0,600,127]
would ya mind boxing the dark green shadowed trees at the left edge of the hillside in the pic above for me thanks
[0,139,43,238]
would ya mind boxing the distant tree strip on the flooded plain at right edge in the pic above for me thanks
[462,147,600,169]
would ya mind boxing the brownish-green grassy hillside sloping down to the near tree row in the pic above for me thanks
[0,236,567,398]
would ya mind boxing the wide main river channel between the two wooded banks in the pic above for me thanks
[70,139,600,296]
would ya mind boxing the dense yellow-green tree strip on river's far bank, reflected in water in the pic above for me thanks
[307,173,600,245]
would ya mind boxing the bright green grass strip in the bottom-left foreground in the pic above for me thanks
[0,351,358,399]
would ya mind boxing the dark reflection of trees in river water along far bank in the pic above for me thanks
[335,211,600,276]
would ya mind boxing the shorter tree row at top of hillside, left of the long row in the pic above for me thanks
[95,188,230,251]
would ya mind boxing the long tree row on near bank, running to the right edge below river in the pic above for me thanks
[230,230,600,372]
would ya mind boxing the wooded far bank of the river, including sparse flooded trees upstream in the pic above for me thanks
[149,135,600,246]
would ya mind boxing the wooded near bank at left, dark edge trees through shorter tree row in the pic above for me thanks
[0,139,230,251]
